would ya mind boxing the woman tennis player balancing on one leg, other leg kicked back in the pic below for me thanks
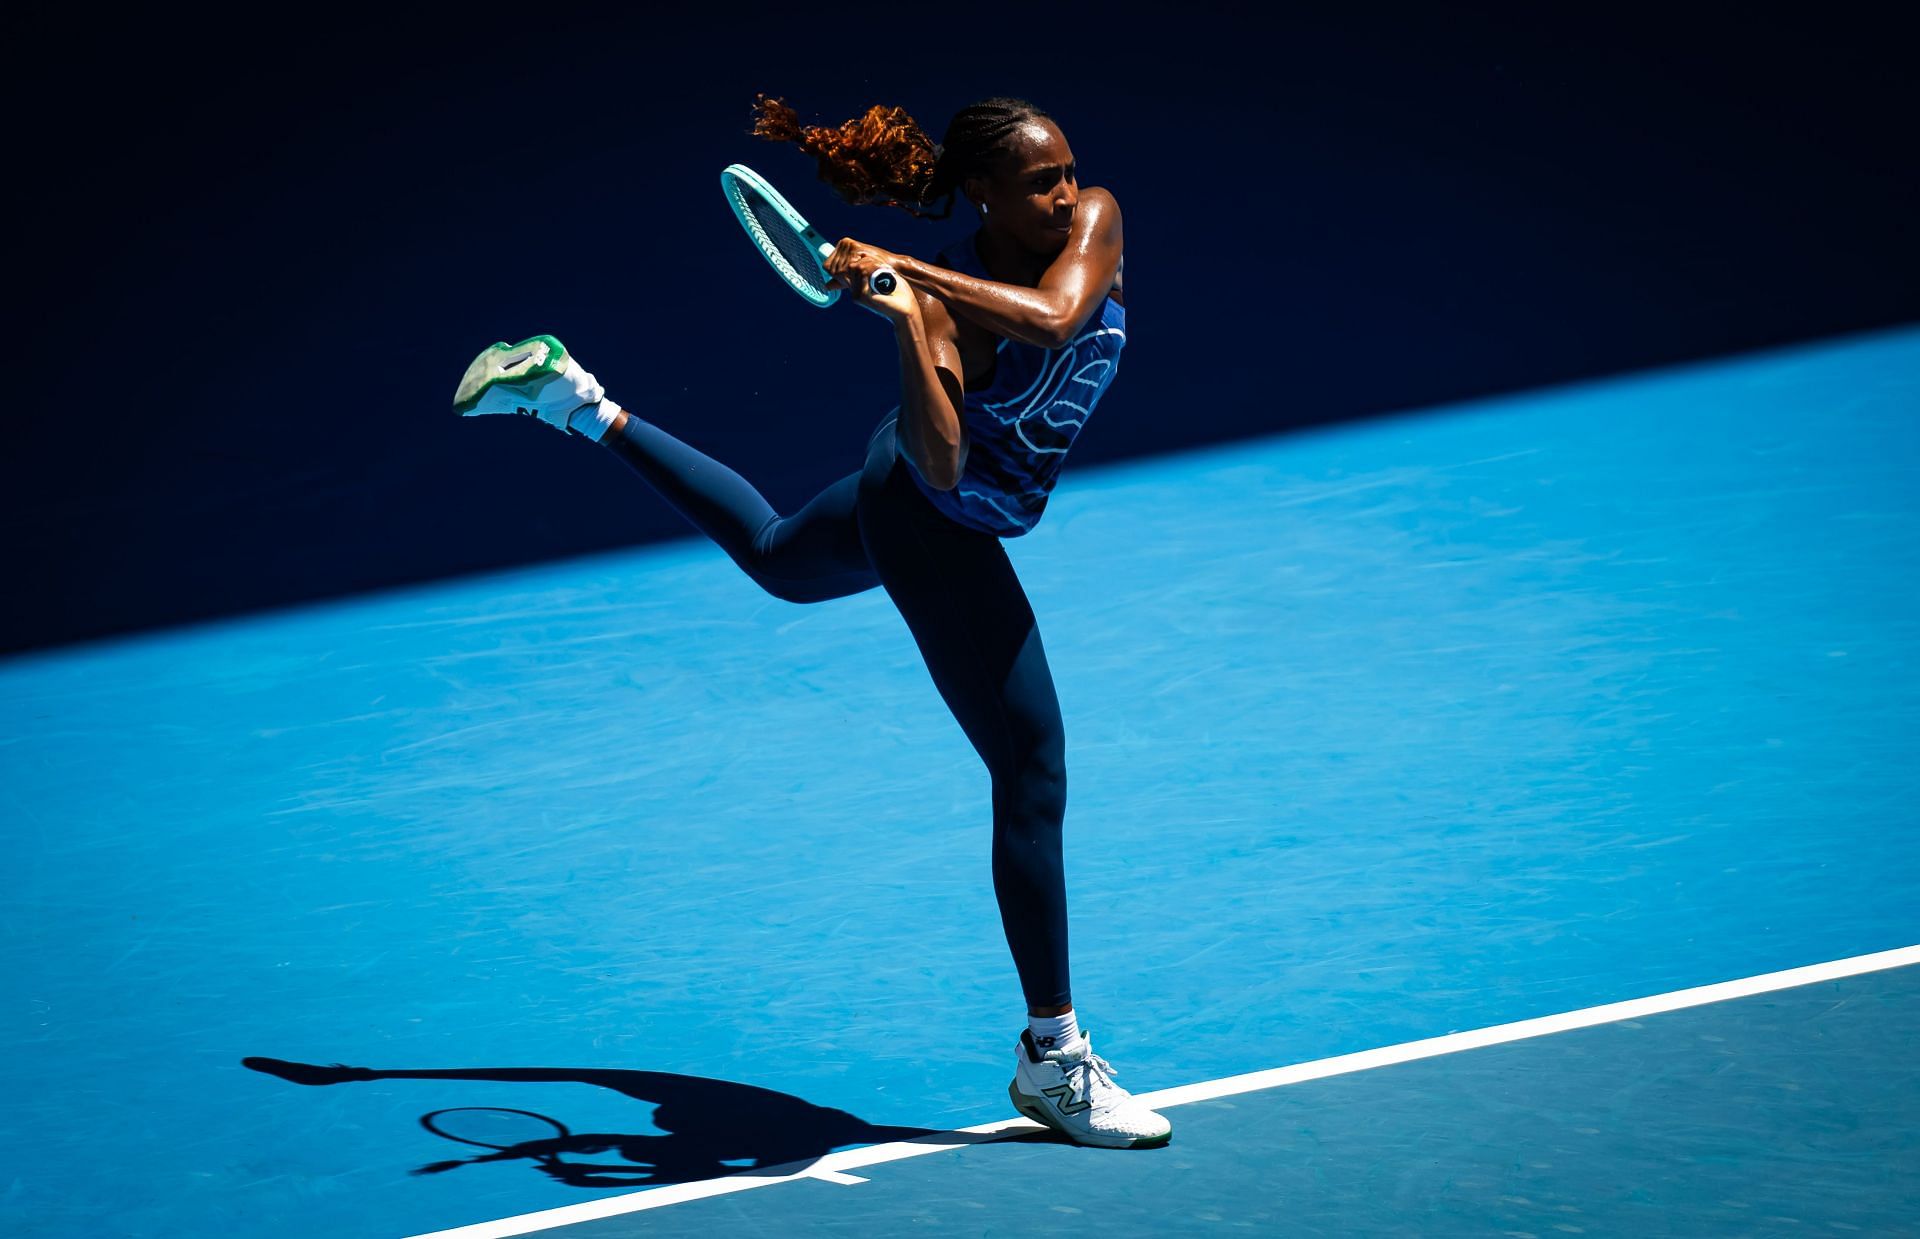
[455,96,1173,1147]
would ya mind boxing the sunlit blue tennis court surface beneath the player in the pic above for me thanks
[0,330,1920,1237]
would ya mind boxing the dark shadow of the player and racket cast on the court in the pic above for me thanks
[240,1058,948,1187]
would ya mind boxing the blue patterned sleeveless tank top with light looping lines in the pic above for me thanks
[902,232,1127,538]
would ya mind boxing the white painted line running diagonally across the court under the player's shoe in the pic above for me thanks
[397,947,1920,1239]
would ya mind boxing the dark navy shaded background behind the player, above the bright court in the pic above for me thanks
[0,4,1920,651]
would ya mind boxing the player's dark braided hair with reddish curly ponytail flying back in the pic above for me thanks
[751,94,1052,219]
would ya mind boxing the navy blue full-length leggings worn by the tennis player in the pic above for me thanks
[607,411,1071,1008]
